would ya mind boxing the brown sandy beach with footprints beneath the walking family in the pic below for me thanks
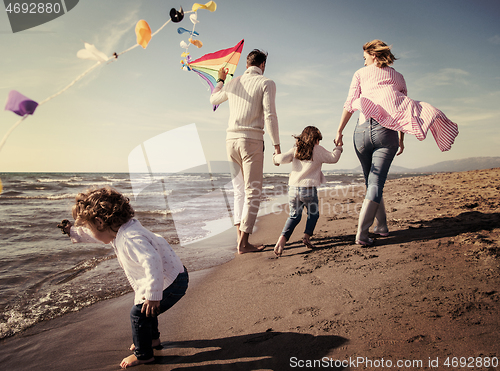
[0,169,500,371]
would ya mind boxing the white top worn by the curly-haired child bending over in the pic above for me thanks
[70,219,184,305]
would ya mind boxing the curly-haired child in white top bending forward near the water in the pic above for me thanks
[58,187,189,368]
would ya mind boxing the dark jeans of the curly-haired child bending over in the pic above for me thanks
[130,267,189,360]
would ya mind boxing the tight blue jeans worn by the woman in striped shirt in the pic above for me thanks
[354,118,399,203]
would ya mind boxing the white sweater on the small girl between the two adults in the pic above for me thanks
[273,144,342,187]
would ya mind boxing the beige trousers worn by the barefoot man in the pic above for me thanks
[226,138,264,233]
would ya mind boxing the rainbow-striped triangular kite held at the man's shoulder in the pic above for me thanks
[186,40,245,111]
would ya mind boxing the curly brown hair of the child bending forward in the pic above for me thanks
[72,187,134,232]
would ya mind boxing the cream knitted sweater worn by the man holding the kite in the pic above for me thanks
[210,66,280,145]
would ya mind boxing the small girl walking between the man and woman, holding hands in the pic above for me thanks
[273,126,342,256]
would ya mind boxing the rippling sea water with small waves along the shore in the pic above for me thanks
[0,173,368,338]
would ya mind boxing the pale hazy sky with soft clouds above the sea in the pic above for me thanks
[0,0,500,173]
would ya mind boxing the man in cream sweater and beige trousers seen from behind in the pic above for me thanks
[210,49,281,254]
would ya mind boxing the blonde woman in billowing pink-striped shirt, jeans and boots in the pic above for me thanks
[335,40,458,245]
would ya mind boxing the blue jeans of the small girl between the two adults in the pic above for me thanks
[281,186,319,241]
